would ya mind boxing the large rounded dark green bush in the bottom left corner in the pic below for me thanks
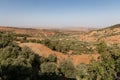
[0,46,38,80]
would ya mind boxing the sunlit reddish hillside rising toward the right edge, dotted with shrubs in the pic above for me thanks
[78,24,120,44]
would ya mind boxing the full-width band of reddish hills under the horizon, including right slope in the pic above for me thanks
[0,24,120,43]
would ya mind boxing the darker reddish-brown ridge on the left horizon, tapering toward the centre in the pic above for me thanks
[0,26,55,37]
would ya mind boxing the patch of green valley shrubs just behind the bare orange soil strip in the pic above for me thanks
[41,39,95,54]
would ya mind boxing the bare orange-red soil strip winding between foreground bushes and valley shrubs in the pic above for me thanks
[19,43,99,66]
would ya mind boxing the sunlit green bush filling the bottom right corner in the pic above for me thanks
[89,46,120,80]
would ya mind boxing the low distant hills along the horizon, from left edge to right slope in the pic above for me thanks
[0,26,89,37]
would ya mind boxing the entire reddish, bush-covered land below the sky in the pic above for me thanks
[0,26,120,80]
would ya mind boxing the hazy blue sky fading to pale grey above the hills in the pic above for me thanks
[0,0,120,27]
